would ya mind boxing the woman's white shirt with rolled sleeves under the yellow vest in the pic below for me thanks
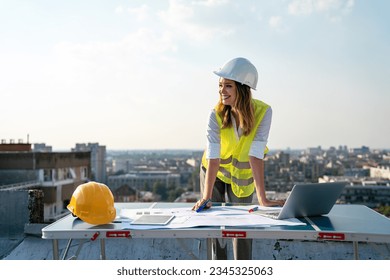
[206,107,272,159]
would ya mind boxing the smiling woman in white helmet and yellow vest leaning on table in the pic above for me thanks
[193,57,283,259]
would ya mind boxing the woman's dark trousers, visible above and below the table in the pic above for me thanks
[199,166,253,260]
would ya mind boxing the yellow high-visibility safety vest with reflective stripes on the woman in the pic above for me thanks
[202,99,269,197]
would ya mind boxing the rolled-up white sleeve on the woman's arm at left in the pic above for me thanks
[206,110,221,159]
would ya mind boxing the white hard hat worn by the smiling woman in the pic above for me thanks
[214,57,258,89]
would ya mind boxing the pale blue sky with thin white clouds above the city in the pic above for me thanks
[0,0,390,150]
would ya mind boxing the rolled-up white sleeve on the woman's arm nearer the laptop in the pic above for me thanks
[249,107,272,159]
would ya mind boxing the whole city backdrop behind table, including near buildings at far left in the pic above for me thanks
[0,140,390,260]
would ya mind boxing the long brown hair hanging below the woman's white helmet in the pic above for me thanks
[217,82,255,136]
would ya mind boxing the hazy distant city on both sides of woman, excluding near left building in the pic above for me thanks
[107,146,390,213]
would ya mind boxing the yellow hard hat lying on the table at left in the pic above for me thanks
[67,181,116,225]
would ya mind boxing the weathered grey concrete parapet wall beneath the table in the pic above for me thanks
[5,236,390,260]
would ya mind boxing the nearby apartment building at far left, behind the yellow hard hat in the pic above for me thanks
[0,143,91,222]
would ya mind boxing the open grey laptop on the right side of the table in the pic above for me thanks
[255,182,347,220]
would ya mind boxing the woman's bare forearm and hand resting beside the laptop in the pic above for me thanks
[249,156,284,206]
